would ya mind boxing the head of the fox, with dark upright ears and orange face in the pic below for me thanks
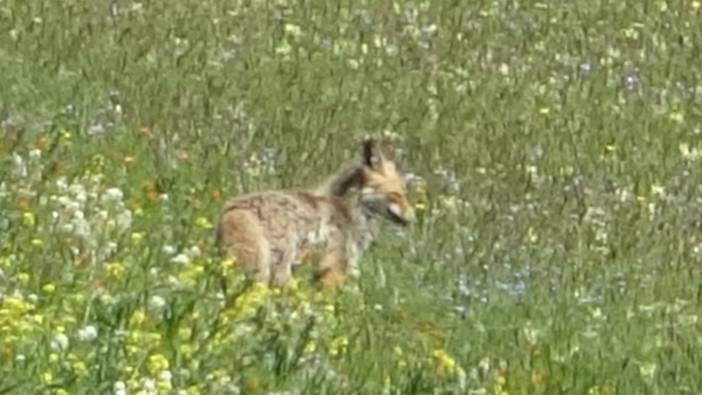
[359,138,415,226]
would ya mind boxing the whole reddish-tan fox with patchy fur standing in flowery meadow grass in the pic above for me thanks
[216,139,415,288]
